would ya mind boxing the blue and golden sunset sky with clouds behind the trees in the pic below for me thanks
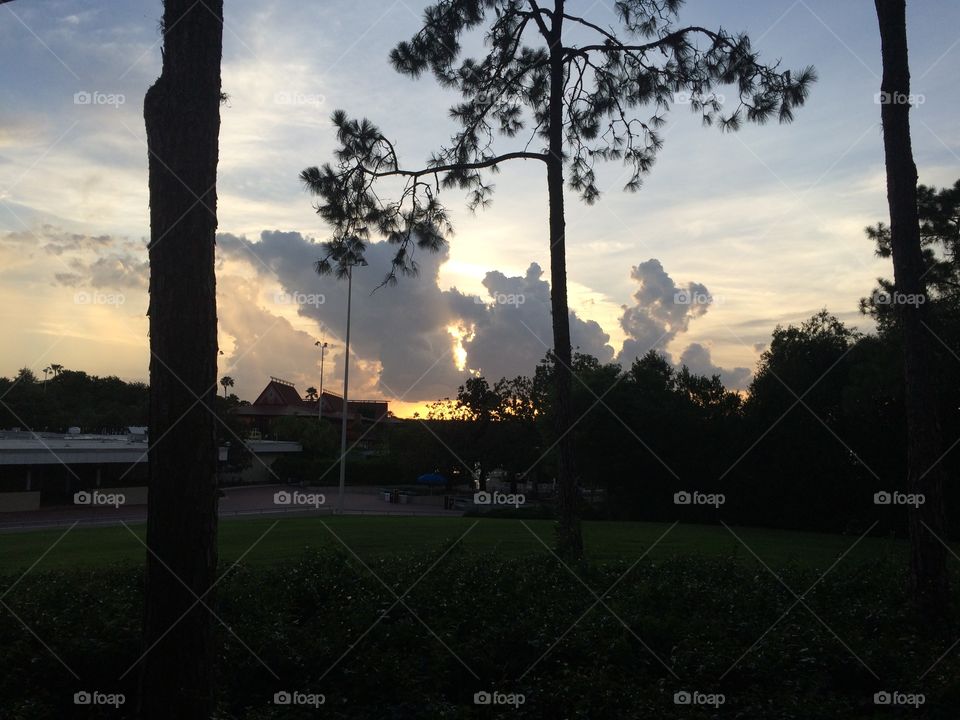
[0,0,960,415]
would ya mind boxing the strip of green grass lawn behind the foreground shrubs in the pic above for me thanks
[0,516,906,573]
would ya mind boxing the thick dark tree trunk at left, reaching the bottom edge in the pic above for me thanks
[140,0,223,720]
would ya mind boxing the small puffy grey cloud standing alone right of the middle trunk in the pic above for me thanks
[618,258,713,367]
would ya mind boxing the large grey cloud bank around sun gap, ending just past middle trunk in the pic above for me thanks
[218,231,613,401]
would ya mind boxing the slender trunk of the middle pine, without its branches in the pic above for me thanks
[547,0,583,558]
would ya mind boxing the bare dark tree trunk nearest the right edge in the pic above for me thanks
[876,0,948,616]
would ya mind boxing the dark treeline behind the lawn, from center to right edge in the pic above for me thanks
[391,182,960,536]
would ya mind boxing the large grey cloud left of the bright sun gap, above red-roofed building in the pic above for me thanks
[218,231,469,401]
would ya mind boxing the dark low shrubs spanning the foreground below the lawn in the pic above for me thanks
[0,552,960,720]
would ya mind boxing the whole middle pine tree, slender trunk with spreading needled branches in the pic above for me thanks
[301,0,815,556]
